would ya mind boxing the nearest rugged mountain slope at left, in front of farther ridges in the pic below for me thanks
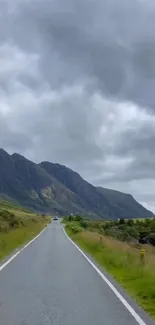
[0,150,86,213]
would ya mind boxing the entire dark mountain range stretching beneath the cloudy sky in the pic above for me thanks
[0,149,153,219]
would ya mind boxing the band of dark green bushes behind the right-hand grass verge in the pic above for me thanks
[64,215,155,245]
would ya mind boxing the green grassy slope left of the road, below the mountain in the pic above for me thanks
[0,202,50,260]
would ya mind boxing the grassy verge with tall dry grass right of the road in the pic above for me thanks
[66,225,155,319]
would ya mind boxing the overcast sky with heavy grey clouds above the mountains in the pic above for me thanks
[0,0,155,211]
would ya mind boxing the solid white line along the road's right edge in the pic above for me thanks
[63,227,147,325]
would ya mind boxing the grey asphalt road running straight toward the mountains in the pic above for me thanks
[0,222,153,325]
